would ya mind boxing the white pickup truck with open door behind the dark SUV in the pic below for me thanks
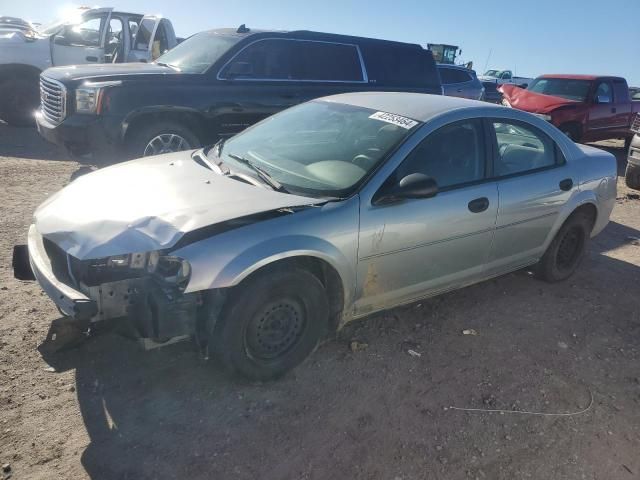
[0,7,178,125]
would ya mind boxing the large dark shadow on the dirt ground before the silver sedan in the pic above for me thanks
[37,219,640,479]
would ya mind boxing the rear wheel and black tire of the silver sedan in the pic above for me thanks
[534,212,592,282]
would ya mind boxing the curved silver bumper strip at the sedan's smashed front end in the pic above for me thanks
[28,225,98,320]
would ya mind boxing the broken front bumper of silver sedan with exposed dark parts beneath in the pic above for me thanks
[14,225,203,339]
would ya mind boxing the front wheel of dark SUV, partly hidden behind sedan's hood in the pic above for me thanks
[127,121,200,158]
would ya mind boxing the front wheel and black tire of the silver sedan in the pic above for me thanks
[210,267,329,381]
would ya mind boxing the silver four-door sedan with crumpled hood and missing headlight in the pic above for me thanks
[20,92,616,379]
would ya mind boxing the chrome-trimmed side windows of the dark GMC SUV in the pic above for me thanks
[222,39,364,82]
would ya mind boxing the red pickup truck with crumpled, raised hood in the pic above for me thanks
[499,75,640,146]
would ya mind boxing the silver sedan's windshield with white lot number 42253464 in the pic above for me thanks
[209,100,419,197]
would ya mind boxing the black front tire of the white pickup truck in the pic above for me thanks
[0,78,40,127]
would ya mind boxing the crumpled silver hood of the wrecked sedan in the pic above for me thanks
[34,152,322,260]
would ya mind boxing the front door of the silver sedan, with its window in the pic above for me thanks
[356,120,498,315]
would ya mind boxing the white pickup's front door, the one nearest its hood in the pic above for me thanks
[51,12,110,67]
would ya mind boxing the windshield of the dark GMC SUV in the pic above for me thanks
[157,32,241,73]
